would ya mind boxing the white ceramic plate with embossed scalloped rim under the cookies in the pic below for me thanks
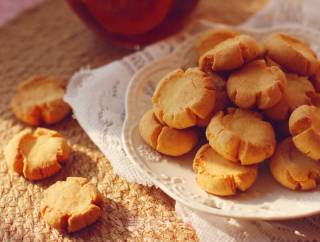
[122,26,320,220]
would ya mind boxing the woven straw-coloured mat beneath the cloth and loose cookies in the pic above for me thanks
[0,0,265,241]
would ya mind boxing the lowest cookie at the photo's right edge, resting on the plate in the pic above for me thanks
[269,138,320,190]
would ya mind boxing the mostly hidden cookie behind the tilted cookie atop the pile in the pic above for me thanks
[196,28,239,56]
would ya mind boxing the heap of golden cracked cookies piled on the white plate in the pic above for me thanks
[139,29,320,196]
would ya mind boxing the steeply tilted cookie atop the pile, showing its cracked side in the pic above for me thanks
[199,34,263,72]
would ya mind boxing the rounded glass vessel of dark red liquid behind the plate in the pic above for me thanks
[67,0,199,48]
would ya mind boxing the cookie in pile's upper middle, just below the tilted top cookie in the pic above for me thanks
[227,60,287,109]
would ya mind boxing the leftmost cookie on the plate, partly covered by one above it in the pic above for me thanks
[139,110,199,156]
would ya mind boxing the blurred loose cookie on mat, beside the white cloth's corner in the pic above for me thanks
[11,76,70,126]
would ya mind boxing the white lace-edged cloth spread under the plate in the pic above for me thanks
[65,0,320,241]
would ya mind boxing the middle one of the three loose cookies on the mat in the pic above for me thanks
[4,128,70,181]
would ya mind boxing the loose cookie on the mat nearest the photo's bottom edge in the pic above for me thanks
[40,177,102,232]
